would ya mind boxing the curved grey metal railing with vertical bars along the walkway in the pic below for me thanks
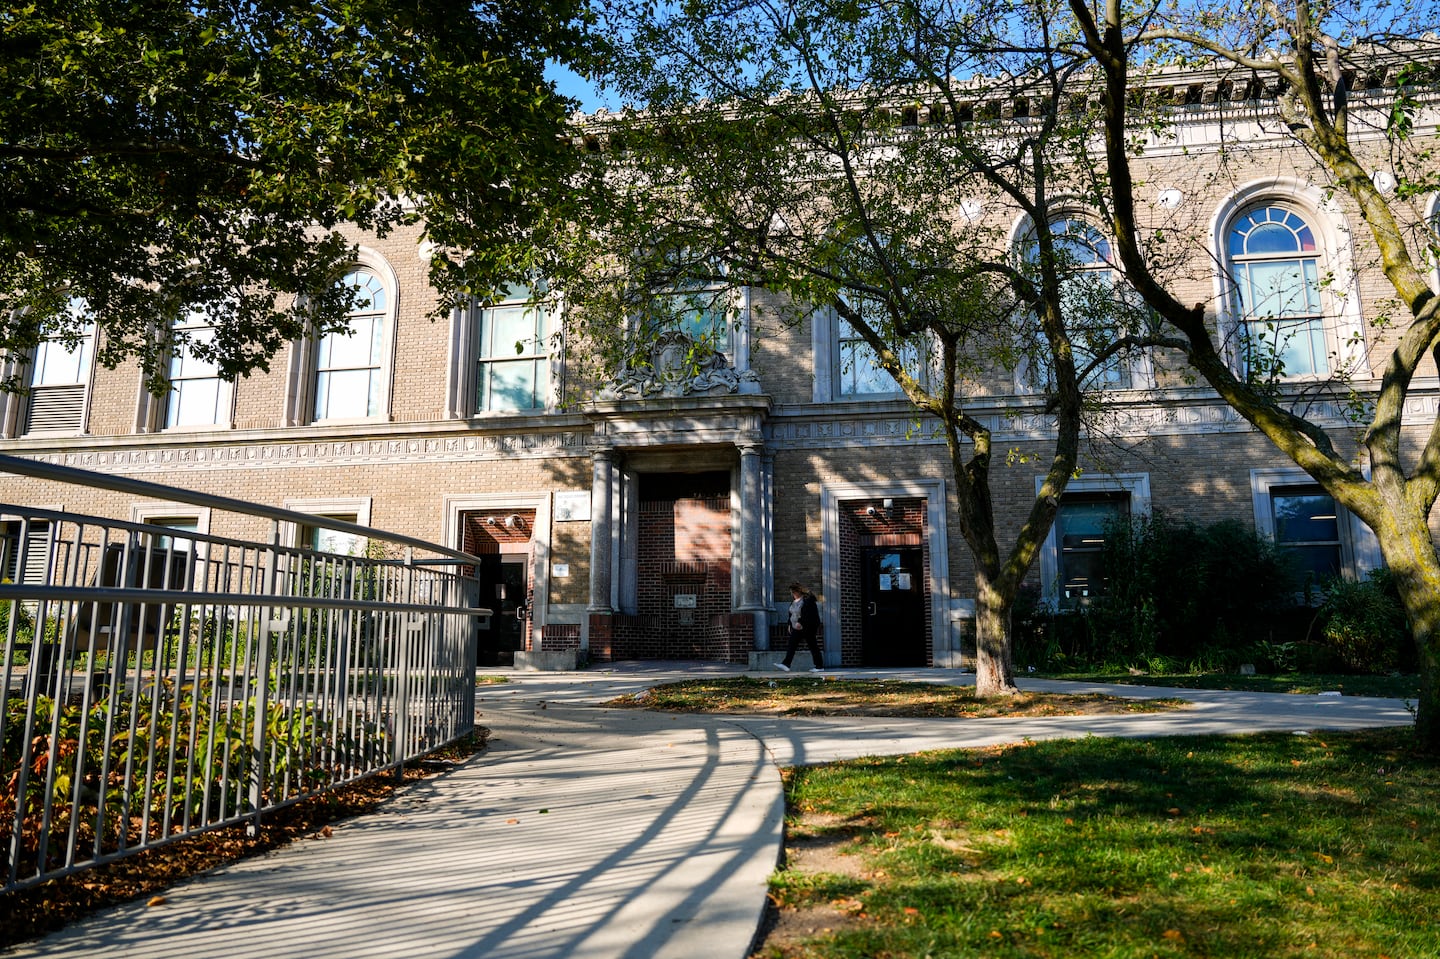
[0,456,488,891]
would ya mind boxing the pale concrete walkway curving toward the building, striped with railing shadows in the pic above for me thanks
[10,664,1411,959]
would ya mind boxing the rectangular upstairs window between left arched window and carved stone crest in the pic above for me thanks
[475,280,550,413]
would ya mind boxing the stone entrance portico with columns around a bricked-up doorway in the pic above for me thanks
[586,393,773,661]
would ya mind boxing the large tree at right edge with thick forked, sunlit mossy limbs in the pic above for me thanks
[1068,0,1440,752]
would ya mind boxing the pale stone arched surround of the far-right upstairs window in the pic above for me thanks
[1210,177,1369,383]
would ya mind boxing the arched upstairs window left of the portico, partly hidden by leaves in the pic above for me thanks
[315,269,390,419]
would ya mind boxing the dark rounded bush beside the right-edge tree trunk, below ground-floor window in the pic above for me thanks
[1316,569,1411,672]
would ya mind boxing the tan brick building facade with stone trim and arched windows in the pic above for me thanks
[0,82,1440,667]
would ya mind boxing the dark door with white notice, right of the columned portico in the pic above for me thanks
[860,546,929,667]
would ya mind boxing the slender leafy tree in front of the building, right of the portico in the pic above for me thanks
[554,0,1143,694]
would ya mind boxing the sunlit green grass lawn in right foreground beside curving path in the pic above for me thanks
[756,730,1440,959]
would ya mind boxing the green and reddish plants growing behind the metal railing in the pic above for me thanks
[0,681,389,875]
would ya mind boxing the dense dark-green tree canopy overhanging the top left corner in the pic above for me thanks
[0,0,585,389]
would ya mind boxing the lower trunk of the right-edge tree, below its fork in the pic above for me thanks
[1375,507,1440,755]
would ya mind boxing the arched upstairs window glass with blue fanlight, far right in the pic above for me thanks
[1227,206,1331,379]
